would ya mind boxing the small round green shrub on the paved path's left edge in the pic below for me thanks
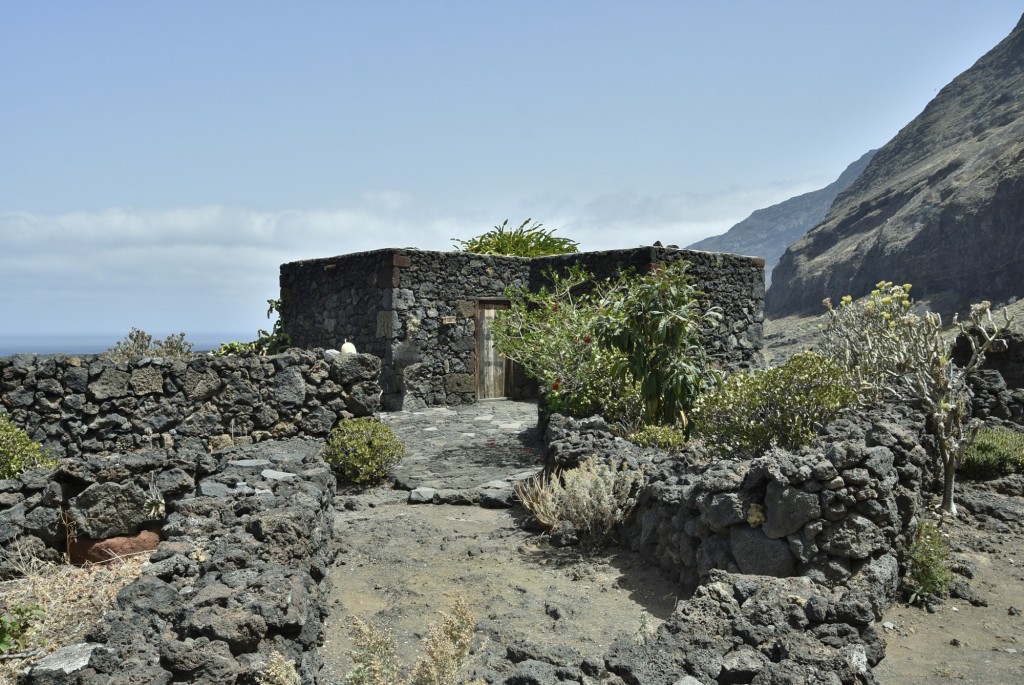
[324,418,406,485]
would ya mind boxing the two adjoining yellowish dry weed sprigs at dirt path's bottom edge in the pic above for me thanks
[345,599,482,685]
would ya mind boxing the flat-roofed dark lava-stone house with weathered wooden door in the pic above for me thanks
[281,246,764,411]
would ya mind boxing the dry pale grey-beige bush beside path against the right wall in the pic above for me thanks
[515,456,643,545]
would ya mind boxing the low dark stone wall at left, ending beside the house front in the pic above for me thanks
[0,349,381,457]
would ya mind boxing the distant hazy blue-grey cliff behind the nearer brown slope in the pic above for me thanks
[688,149,878,286]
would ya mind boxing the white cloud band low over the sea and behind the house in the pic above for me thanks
[0,179,807,335]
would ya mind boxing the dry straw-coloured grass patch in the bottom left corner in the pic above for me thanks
[0,545,150,683]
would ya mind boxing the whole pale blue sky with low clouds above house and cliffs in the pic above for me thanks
[0,0,1024,337]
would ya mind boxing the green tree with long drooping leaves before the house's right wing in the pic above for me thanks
[594,260,721,431]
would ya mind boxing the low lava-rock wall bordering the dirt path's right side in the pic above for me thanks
[547,406,936,685]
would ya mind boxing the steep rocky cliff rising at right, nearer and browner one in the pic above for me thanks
[765,12,1024,317]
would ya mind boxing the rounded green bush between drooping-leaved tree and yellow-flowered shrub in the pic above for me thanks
[693,352,857,455]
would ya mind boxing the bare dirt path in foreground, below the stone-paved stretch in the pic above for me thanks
[321,494,676,682]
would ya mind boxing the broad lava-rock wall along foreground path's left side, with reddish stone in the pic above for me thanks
[7,438,335,685]
